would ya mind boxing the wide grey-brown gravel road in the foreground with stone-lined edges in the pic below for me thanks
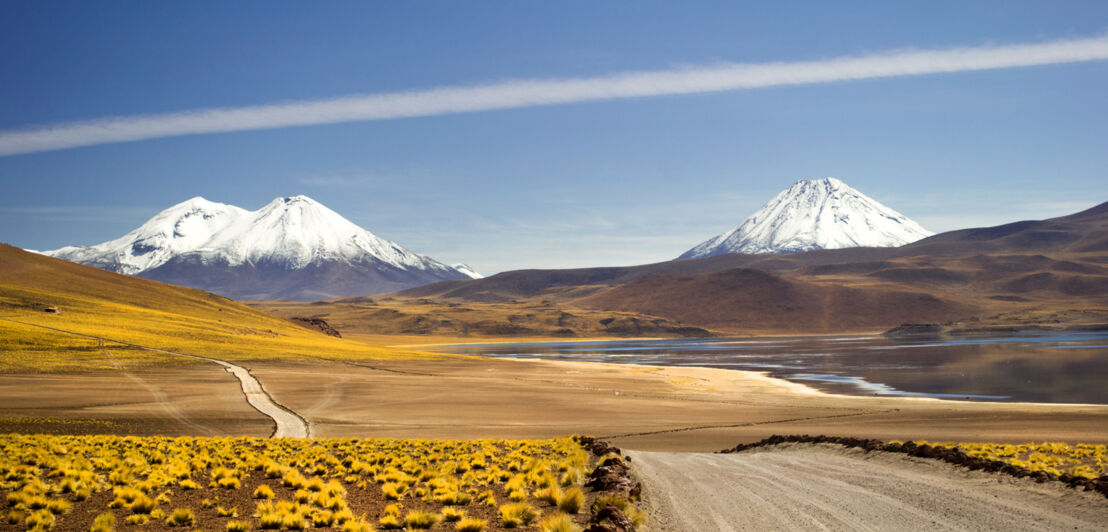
[629,444,1108,531]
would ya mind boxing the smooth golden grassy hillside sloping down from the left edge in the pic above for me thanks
[0,245,441,371]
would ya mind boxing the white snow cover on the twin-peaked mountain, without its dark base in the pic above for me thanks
[44,195,463,275]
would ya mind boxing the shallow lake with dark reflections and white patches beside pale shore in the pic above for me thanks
[437,331,1108,405]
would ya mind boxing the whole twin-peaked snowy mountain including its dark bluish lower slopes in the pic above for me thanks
[43,196,472,300]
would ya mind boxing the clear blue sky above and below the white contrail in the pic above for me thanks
[0,1,1108,274]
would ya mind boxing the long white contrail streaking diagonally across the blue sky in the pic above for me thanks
[0,35,1108,156]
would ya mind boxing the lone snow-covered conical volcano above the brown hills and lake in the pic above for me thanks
[678,177,934,258]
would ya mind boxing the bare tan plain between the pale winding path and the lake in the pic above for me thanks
[247,358,1108,452]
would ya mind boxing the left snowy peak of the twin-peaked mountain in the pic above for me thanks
[42,196,248,275]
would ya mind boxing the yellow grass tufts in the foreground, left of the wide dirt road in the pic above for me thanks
[0,434,624,531]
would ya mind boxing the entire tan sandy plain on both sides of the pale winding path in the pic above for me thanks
[0,350,1108,452]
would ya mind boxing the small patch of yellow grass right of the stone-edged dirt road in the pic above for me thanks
[908,440,1108,479]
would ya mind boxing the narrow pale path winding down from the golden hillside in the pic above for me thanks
[0,318,311,438]
